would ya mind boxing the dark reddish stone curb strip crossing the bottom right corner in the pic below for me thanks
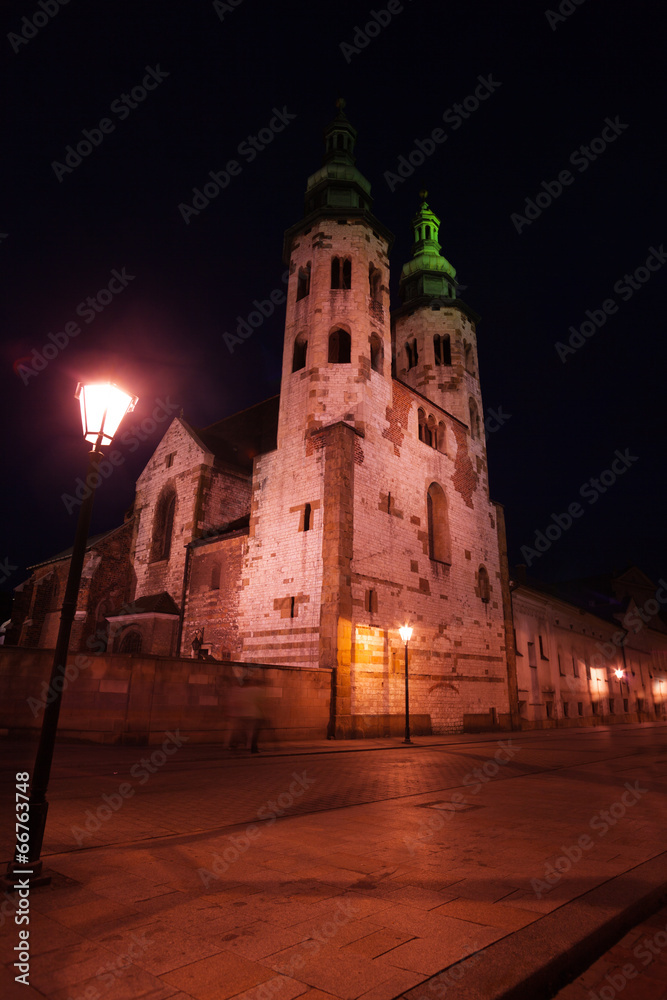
[401,852,667,1000]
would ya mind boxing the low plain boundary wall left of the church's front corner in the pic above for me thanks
[0,646,331,744]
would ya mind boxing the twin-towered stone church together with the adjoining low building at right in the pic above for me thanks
[7,108,667,736]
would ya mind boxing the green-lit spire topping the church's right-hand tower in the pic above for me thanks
[399,191,456,302]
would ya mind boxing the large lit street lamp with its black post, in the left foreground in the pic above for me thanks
[4,382,137,886]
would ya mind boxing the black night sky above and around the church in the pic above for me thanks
[0,0,667,590]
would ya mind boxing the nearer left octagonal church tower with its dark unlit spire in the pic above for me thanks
[278,101,393,447]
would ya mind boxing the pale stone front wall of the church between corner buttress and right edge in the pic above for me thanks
[351,366,509,732]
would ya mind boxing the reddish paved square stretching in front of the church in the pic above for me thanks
[0,724,667,1000]
